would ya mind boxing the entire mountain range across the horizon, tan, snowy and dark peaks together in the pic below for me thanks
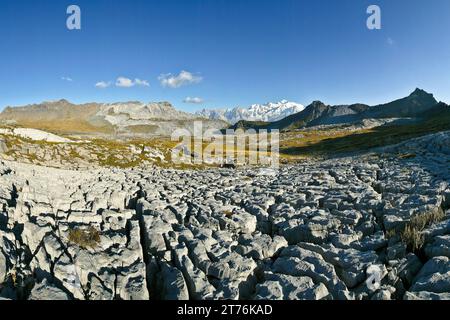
[0,89,450,137]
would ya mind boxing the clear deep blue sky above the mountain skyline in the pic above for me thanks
[0,0,450,111]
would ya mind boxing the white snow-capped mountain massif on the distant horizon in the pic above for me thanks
[196,100,305,124]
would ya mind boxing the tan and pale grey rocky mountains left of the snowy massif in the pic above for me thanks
[0,99,228,136]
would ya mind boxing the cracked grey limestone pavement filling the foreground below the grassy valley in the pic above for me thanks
[0,133,450,300]
